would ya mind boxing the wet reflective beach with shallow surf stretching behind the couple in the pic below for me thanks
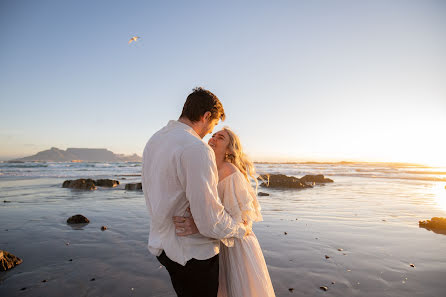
[0,162,446,297]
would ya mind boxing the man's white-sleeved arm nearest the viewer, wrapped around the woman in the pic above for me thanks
[178,144,246,239]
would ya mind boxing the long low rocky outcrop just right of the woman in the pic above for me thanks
[259,174,333,189]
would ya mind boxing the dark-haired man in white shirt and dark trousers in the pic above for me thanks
[142,88,249,297]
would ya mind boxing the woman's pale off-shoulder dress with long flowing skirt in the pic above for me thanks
[218,170,275,297]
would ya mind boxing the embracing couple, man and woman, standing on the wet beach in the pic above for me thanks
[142,88,275,297]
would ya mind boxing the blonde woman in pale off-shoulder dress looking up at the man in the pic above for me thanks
[176,128,275,297]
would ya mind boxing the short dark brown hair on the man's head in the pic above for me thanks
[180,87,225,122]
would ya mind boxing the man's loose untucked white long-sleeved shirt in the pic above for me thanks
[141,121,245,265]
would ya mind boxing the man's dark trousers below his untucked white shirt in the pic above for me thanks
[157,251,218,297]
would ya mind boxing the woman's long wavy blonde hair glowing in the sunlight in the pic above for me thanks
[223,127,259,192]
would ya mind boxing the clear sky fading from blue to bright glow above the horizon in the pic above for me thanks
[0,0,446,165]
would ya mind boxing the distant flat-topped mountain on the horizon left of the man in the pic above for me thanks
[11,147,142,162]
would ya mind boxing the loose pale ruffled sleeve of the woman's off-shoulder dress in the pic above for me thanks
[224,172,263,224]
